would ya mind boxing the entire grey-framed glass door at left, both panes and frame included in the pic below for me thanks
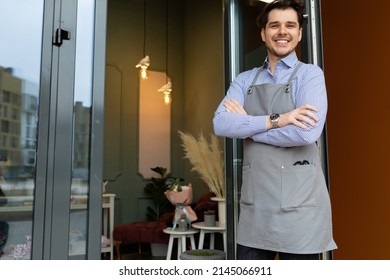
[0,0,107,259]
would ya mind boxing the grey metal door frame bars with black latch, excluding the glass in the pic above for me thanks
[31,0,107,259]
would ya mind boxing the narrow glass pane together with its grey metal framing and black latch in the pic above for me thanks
[33,0,106,259]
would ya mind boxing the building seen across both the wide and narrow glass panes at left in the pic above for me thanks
[0,66,91,182]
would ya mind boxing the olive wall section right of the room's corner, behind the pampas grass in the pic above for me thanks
[184,0,225,196]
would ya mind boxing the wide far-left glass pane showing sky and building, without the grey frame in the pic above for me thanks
[0,0,44,259]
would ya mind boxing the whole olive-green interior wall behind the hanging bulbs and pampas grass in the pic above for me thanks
[104,0,224,224]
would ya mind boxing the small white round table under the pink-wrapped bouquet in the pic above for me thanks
[163,227,199,260]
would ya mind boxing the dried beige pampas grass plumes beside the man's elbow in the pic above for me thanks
[178,130,225,198]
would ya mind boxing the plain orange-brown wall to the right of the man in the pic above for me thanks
[321,0,390,259]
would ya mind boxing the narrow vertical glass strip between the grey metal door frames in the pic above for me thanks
[69,0,94,258]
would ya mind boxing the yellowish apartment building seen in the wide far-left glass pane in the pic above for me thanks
[0,66,38,182]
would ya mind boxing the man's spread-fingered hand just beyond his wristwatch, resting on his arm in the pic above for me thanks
[279,104,319,129]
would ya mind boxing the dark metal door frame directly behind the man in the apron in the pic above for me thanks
[224,0,332,260]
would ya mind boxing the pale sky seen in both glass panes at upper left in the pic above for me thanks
[0,0,94,106]
